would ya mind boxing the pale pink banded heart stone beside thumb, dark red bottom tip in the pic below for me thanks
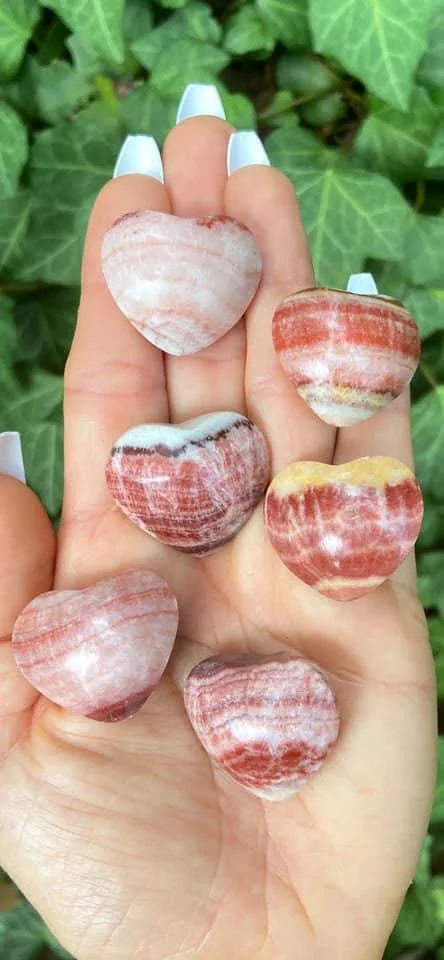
[12,570,178,722]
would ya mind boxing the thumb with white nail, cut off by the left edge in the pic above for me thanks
[0,433,56,757]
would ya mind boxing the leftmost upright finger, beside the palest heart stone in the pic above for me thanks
[63,165,170,529]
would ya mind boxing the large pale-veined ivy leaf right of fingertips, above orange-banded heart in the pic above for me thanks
[267,124,410,287]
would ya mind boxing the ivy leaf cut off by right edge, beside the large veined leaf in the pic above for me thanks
[404,214,444,287]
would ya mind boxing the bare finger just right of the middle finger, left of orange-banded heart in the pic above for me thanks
[225,146,336,473]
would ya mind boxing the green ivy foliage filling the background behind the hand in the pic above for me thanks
[0,0,444,960]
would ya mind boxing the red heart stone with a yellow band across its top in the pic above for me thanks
[265,457,423,600]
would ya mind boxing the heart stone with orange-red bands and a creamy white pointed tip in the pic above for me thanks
[272,289,420,427]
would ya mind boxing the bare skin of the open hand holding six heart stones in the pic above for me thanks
[0,118,435,960]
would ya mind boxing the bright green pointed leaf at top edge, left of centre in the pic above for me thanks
[42,0,125,63]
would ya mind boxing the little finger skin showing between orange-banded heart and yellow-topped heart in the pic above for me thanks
[334,388,416,589]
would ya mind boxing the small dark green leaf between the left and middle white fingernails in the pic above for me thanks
[121,82,177,143]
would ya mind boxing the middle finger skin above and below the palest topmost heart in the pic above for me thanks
[164,117,245,422]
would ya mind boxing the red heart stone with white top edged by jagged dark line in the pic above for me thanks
[106,412,270,556]
